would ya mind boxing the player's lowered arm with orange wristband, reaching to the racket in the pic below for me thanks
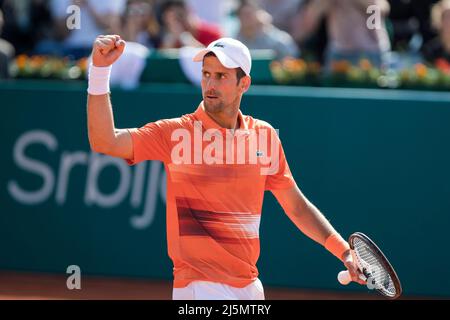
[272,185,364,284]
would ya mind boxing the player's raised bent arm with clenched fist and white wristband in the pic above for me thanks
[87,35,133,159]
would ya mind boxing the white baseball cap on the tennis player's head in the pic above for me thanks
[193,38,252,76]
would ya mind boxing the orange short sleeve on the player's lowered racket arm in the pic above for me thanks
[265,129,295,190]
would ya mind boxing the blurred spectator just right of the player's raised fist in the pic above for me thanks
[123,0,161,49]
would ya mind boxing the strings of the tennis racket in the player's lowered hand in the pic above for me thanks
[353,238,397,296]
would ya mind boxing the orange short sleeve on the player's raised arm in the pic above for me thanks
[126,120,170,165]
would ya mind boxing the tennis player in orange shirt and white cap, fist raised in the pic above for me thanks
[87,35,364,300]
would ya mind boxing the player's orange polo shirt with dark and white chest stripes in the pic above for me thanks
[127,103,295,288]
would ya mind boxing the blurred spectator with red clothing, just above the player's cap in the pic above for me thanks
[161,0,222,48]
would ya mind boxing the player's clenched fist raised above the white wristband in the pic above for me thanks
[92,35,125,67]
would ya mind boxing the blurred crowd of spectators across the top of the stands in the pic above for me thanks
[0,0,450,78]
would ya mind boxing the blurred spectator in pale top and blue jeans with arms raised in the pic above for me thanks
[298,0,390,70]
